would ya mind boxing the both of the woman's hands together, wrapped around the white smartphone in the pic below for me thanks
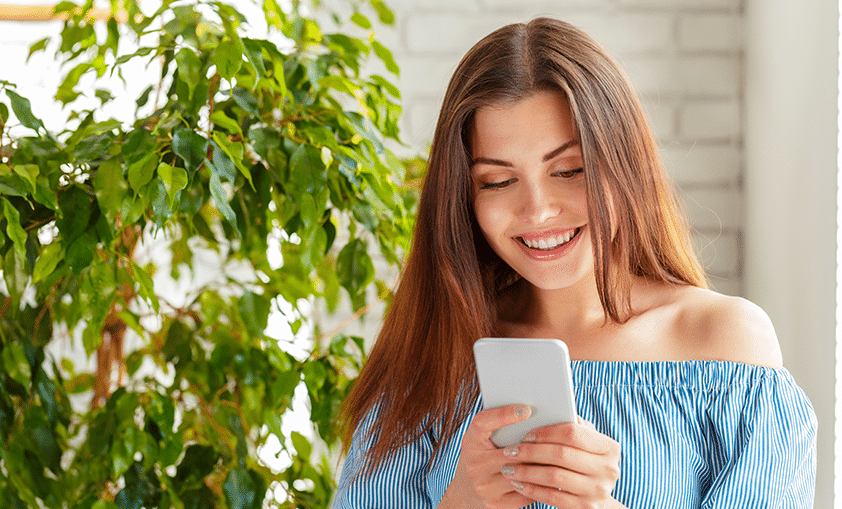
[439,405,622,509]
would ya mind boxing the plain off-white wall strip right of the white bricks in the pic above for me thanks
[743,0,839,508]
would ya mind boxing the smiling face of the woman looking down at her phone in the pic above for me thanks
[470,92,594,290]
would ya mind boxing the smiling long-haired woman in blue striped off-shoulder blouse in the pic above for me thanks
[335,18,816,508]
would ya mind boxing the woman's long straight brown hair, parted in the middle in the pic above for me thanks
[342,18,706,468]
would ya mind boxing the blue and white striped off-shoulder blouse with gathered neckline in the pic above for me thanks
[333,361,816,509]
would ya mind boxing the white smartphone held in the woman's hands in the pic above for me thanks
[474,338,576,447]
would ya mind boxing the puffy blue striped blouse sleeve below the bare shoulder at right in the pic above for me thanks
[702,369,816,509]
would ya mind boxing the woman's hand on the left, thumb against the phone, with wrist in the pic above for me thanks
[439,405,534,509]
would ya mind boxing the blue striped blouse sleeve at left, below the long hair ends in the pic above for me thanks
[333,408,433,509]
